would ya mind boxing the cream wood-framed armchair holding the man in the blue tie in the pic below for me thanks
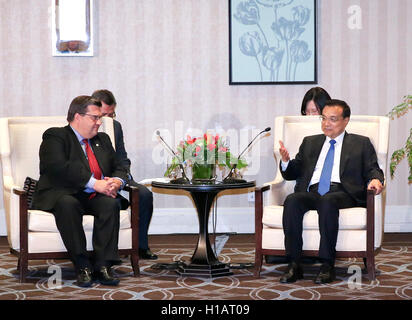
[255,115,389,279]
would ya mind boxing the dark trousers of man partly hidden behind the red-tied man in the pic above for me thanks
[128,180,153,249]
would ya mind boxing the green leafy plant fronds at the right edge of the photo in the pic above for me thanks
[387,95,412,184]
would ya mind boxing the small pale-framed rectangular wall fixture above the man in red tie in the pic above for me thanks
[51,0,93,57]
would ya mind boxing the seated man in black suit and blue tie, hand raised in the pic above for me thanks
[279,100,384,284]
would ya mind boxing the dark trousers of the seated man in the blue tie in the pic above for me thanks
[283,185,356,265]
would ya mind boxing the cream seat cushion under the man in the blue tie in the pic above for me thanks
[262,206,366,230]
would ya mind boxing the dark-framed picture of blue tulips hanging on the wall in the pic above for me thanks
[229,0,317,85]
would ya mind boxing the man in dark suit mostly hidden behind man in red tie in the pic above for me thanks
[92,89,157,260]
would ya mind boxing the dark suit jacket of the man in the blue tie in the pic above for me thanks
[281,132,384,206]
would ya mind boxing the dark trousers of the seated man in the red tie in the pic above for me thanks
[52,192,121,269]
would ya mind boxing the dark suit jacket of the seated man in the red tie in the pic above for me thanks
[33,125,127,211]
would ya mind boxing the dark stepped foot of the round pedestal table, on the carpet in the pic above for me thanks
[176,263,233,278]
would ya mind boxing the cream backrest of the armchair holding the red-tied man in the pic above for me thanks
[0,116,114,248]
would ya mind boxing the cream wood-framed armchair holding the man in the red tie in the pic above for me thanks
[0,117,139,282]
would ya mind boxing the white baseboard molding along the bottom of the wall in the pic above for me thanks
[0,205,412,236]
